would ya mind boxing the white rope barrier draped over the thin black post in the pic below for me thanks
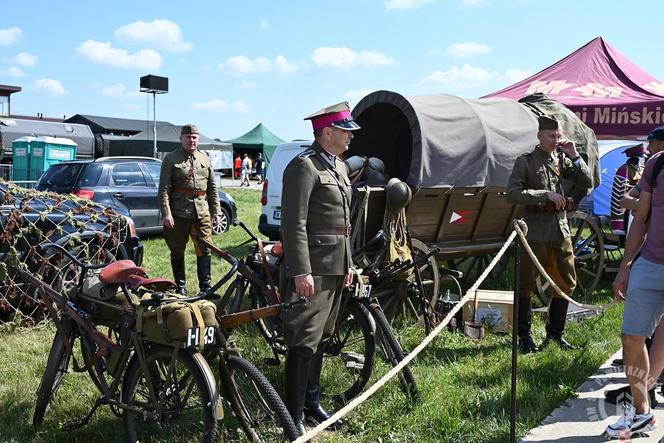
[295,220,586,443]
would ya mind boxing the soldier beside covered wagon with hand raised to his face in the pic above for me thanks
[507,116,592,353]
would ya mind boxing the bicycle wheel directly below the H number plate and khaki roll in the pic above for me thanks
[122,345,219,442]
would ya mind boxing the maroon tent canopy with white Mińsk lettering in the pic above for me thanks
[482,37,664,138]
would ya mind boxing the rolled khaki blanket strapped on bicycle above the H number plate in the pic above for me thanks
[136,295,219,347]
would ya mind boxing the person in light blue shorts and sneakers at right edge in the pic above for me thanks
[606,148,664,438]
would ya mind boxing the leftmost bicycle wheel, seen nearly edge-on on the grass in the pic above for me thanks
[32,319,74,426]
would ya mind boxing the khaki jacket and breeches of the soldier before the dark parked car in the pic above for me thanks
[159,148,220,257]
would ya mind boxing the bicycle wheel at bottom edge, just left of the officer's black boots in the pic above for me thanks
[219,355,298,442]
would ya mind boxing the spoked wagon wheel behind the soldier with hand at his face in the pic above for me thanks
[537,211,604,306]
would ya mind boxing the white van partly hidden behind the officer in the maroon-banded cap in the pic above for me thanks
[258,140,313,240]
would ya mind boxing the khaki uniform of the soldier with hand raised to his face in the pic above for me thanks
[507,146,592,297]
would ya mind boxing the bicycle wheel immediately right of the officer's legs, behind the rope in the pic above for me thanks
[321,298,376,405]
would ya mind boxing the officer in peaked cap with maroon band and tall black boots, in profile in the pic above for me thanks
[281,102,360,432]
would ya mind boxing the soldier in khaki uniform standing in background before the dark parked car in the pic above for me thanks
[159,124,220,294]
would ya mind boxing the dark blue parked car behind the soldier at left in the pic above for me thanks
[36,157,237,235]
